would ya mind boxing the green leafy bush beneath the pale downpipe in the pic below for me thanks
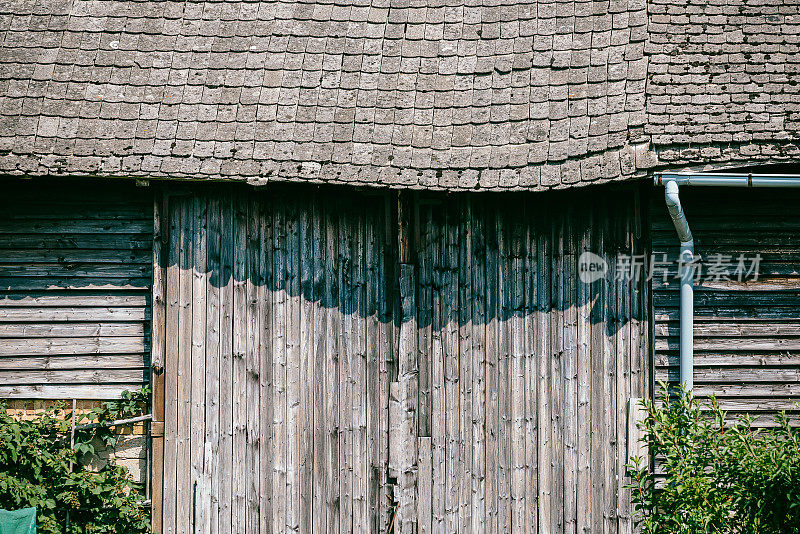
[629,388,800,534]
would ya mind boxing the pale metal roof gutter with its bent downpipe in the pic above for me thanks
[653,173,800,391]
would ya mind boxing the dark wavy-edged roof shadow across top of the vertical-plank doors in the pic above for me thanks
[162,185,646,335]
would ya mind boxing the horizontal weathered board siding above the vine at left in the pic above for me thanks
[0,179,153,399]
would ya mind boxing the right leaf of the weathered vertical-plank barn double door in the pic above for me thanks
[406,191,649,533]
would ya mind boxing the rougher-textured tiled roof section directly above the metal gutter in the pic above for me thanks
[646,0,800,165]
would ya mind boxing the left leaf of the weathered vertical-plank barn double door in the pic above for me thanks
[154,187,392,533]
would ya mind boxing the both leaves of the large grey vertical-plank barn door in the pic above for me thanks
[156,187,649,533]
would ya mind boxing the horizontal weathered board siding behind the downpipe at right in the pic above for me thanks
[650,187,800,425]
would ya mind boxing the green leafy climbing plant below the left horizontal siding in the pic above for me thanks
[0,390,150,534]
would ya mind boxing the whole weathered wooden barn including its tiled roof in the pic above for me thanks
[0,0,800,534]
